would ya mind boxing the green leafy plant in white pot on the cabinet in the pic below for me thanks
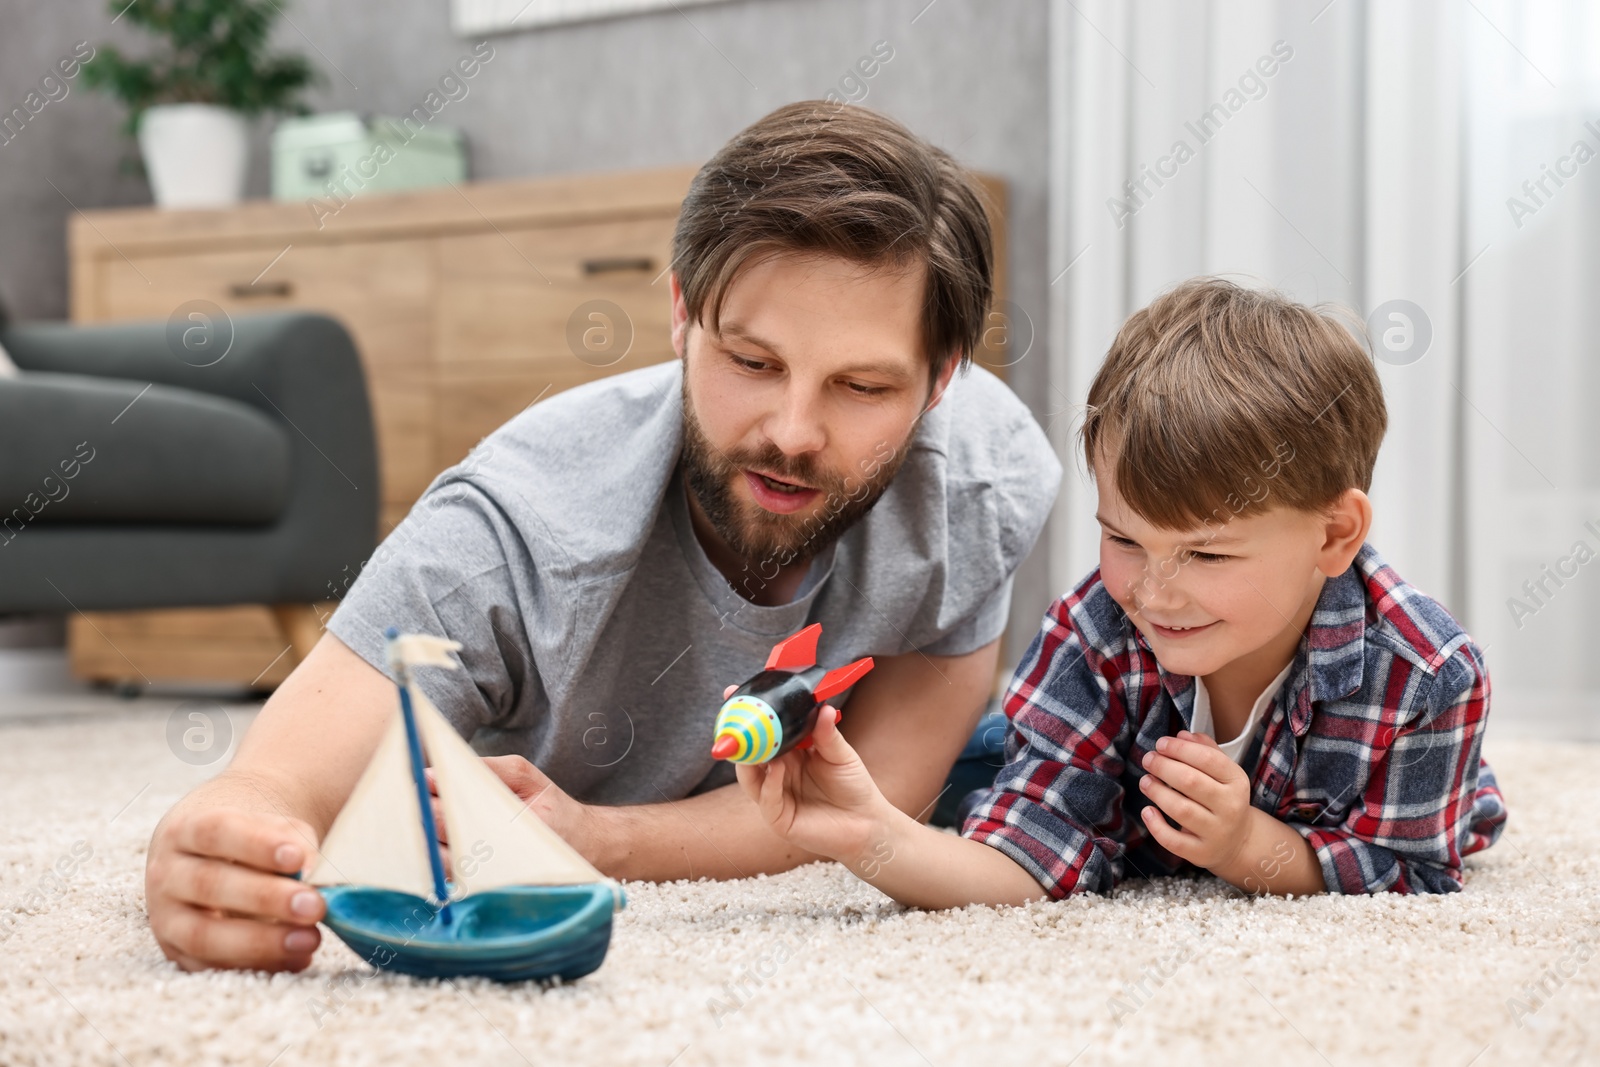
[83,0,317,208]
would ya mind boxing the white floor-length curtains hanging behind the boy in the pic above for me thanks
[1048,0,1600,733]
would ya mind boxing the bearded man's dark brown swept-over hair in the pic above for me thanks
[672,101,994,381]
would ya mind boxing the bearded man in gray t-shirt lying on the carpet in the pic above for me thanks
[146,101,1061,969]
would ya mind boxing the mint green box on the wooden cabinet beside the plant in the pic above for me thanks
[272,109,467,200]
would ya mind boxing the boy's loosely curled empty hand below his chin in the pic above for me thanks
[1139,729,1251,870]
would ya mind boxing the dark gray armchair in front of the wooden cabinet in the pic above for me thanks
[0,312,378,614]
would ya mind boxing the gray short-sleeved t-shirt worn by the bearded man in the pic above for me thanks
[328,360,1061,803]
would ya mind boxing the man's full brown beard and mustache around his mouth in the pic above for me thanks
[682,382,922,566]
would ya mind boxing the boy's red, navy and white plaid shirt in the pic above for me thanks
[962,544,1506,897]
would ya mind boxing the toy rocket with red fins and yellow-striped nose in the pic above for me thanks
[710,622,872,763]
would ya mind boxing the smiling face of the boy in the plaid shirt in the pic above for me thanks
[1094,447,1331,677]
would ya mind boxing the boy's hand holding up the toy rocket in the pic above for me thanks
[734,705,898,865]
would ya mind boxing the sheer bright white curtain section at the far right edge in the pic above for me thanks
[1462,0,1600,739]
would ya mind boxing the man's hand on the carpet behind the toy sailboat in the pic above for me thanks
[144,808,326,971]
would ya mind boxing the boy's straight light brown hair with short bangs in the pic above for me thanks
[1080,278,1387,530]
